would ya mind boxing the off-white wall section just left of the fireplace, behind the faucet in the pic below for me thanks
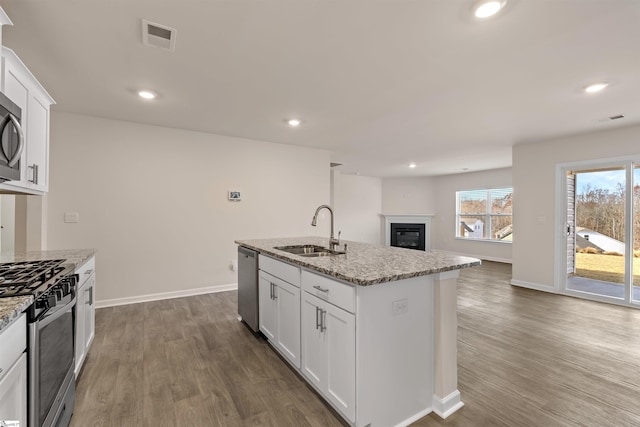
[332,170,384,245]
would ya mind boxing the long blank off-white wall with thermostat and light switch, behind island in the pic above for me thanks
[46,112,330,302]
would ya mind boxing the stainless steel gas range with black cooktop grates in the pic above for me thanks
[0,260,78,427]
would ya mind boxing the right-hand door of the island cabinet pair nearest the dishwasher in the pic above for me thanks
[276,280,300,368]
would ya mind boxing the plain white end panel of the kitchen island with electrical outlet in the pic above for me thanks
[356,276,434,426]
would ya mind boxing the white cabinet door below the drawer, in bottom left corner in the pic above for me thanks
[0,353,27,426]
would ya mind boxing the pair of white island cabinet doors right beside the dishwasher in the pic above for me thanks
[258,271,300,368]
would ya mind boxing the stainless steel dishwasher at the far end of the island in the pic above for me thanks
[238,246,259,332]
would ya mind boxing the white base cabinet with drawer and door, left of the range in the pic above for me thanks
[0,314,27,426]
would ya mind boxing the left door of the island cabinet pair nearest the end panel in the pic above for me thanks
[300,292,327,390]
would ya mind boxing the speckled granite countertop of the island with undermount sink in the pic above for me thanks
[236,237,481,286]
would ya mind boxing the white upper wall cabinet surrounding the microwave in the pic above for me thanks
[0,47,54,194]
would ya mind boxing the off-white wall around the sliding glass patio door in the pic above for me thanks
[512,126,640,287]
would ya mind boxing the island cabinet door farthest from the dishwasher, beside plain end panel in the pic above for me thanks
[325,304,356,422]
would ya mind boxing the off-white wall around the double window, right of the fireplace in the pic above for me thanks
[432,168,520,262]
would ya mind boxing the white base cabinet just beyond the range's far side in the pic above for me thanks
[75,257,96,378]
